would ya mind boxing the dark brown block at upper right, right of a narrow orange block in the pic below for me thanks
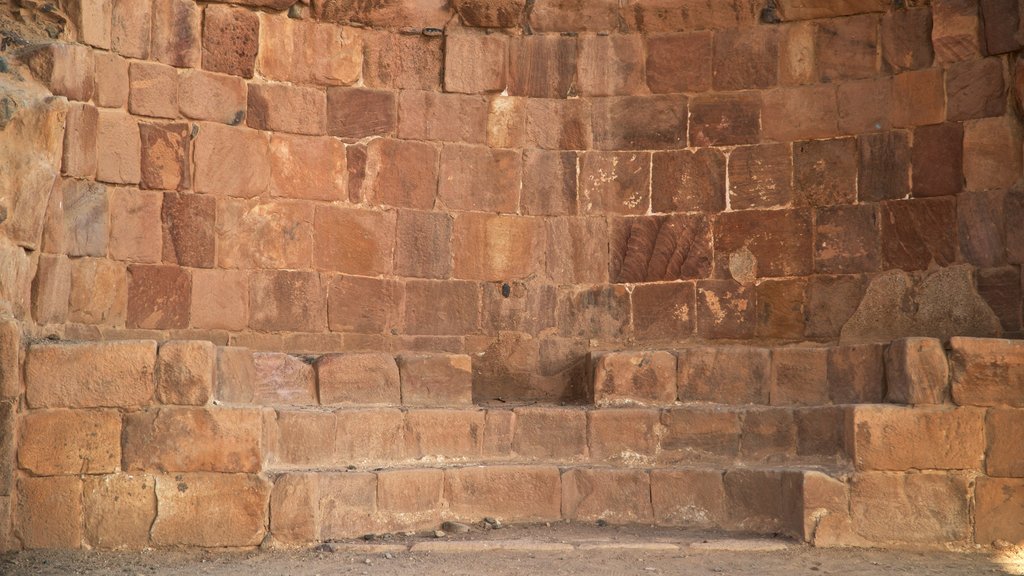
[946,57,1007,120]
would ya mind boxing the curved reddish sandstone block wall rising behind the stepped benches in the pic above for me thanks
[4,0,1024,400]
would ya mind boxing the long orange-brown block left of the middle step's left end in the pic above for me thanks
[123,407,261,472]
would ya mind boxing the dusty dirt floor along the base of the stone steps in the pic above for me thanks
[0,525,1024,576]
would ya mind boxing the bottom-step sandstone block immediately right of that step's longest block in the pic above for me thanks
[562,468,654,524]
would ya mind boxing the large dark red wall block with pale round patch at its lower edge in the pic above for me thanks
[716,210,812,278]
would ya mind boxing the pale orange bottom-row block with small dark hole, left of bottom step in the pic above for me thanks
[151,474,270,547]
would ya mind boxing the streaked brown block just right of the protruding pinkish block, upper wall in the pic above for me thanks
[508,35,577,98]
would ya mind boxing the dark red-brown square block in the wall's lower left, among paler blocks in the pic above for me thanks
[128,264,191,329]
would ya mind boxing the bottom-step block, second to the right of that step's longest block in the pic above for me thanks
[650,469,726,528]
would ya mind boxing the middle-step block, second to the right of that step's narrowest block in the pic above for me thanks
[588,409,660,466]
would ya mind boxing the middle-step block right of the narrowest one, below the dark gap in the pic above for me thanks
[512,407,587,462]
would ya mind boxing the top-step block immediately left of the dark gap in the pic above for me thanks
[397,354,473,406]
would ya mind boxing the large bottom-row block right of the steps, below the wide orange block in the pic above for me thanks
[850,472,971,546]
